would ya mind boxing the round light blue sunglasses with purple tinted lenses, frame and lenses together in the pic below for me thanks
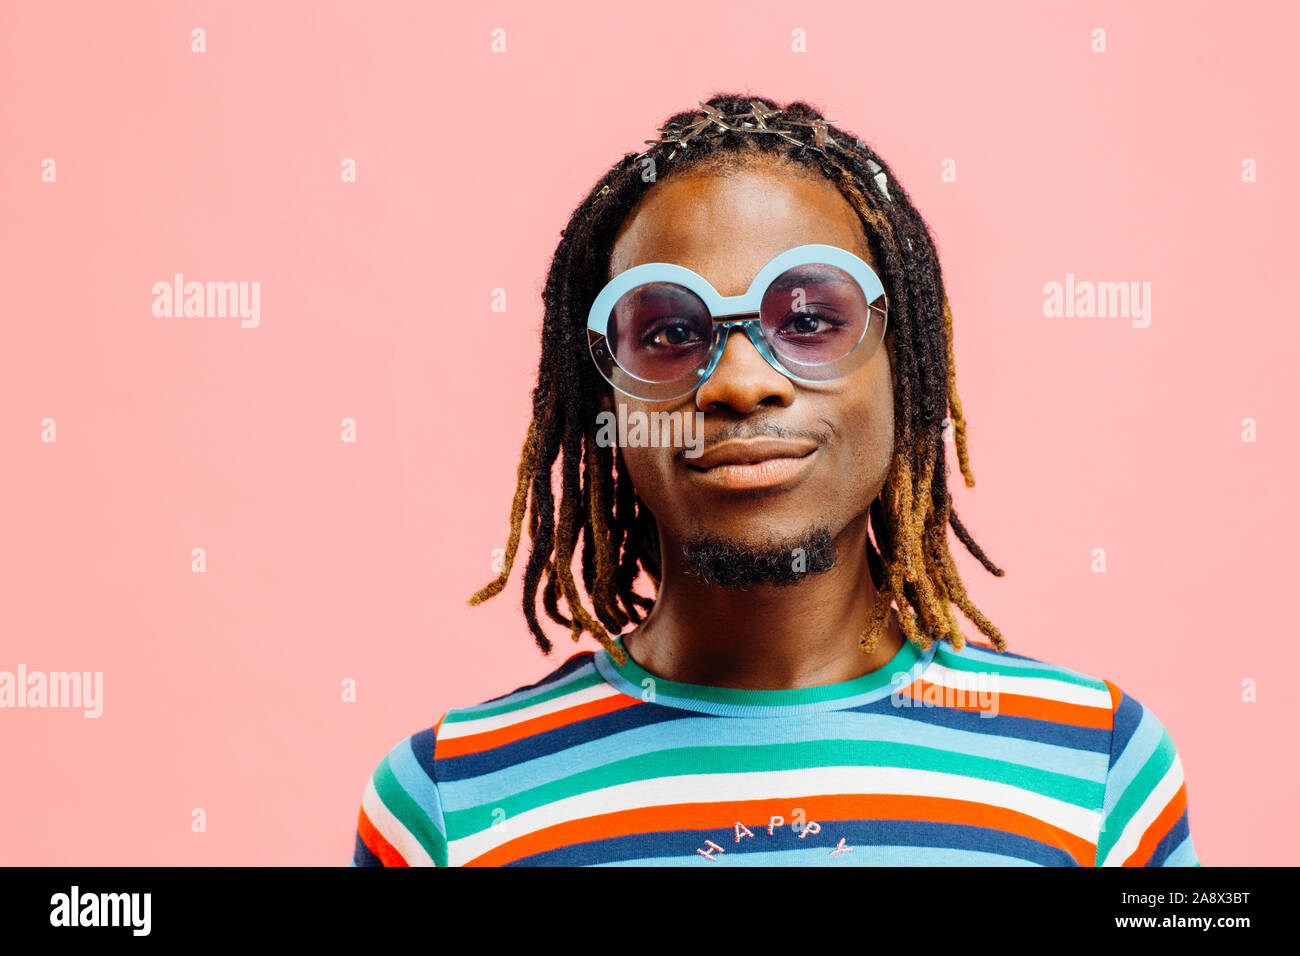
[586,243,888,402]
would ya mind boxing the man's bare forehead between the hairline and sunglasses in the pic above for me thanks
[608,164,876,295]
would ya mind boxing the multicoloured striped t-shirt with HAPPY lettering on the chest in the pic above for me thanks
[351,641,1200,866]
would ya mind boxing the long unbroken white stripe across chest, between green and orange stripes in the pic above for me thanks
[449,766,1097,866]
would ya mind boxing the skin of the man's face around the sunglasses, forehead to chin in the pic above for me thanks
[610,164,893,584]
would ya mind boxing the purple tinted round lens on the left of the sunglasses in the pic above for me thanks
[608,282,714,382]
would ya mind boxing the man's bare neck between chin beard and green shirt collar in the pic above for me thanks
[623,515,905,691]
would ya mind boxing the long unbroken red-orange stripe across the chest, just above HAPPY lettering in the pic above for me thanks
[465,793,1097,866]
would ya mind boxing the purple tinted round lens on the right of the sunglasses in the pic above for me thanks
[761,264,871,365]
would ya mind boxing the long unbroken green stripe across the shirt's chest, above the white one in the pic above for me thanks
[445,740,1104,834]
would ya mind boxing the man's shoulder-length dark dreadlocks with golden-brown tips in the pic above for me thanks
[469,94,1006,663]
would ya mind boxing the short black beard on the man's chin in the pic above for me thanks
[681,528,835,588]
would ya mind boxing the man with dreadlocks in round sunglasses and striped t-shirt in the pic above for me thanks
[352,96,1200,866]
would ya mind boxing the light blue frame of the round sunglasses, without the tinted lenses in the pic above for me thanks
[586,243,889,402]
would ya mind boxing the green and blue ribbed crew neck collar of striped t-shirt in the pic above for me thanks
[593,635,939,717]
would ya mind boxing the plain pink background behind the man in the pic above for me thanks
[0,0,1300,865]
